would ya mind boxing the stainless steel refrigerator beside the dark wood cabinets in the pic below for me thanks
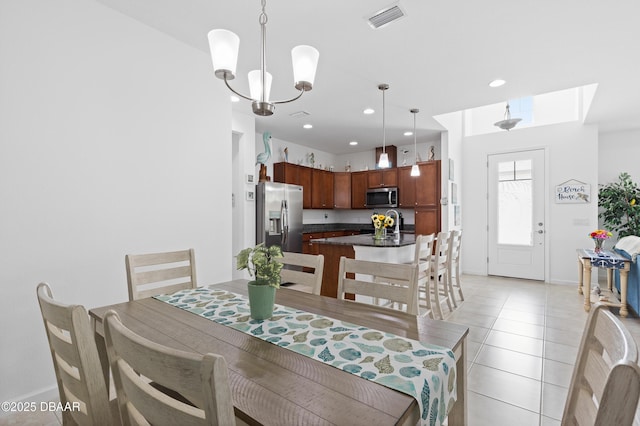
[256,182,302,253]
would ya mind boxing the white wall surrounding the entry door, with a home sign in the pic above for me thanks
[462,123,598,284]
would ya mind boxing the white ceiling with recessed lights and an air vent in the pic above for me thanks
[98,0,640,154]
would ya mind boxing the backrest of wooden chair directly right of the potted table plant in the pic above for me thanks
[277,252,324,295]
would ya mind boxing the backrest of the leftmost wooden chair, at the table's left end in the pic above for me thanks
[36,283,114,425]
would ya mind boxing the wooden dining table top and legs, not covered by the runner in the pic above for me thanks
[89,280,469,426]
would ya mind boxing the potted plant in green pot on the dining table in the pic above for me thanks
[236,243,282,320]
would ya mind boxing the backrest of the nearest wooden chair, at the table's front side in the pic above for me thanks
[104,311,235,426]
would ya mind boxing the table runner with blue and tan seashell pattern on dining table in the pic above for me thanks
[154,287,457,425]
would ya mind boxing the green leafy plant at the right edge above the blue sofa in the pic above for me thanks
[598,172,640,238]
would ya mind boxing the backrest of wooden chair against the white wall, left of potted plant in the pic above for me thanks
[125,249,197,300]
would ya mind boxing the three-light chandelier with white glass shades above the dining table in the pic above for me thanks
[208,0,320,116]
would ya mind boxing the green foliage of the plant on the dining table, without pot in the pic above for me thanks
[236,243,283,288]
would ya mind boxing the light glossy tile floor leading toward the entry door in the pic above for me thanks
[5,275,640,426]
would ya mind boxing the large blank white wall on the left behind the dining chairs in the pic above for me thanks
[0,0,231,401]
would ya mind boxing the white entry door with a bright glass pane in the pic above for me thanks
[487,149,545,280]
